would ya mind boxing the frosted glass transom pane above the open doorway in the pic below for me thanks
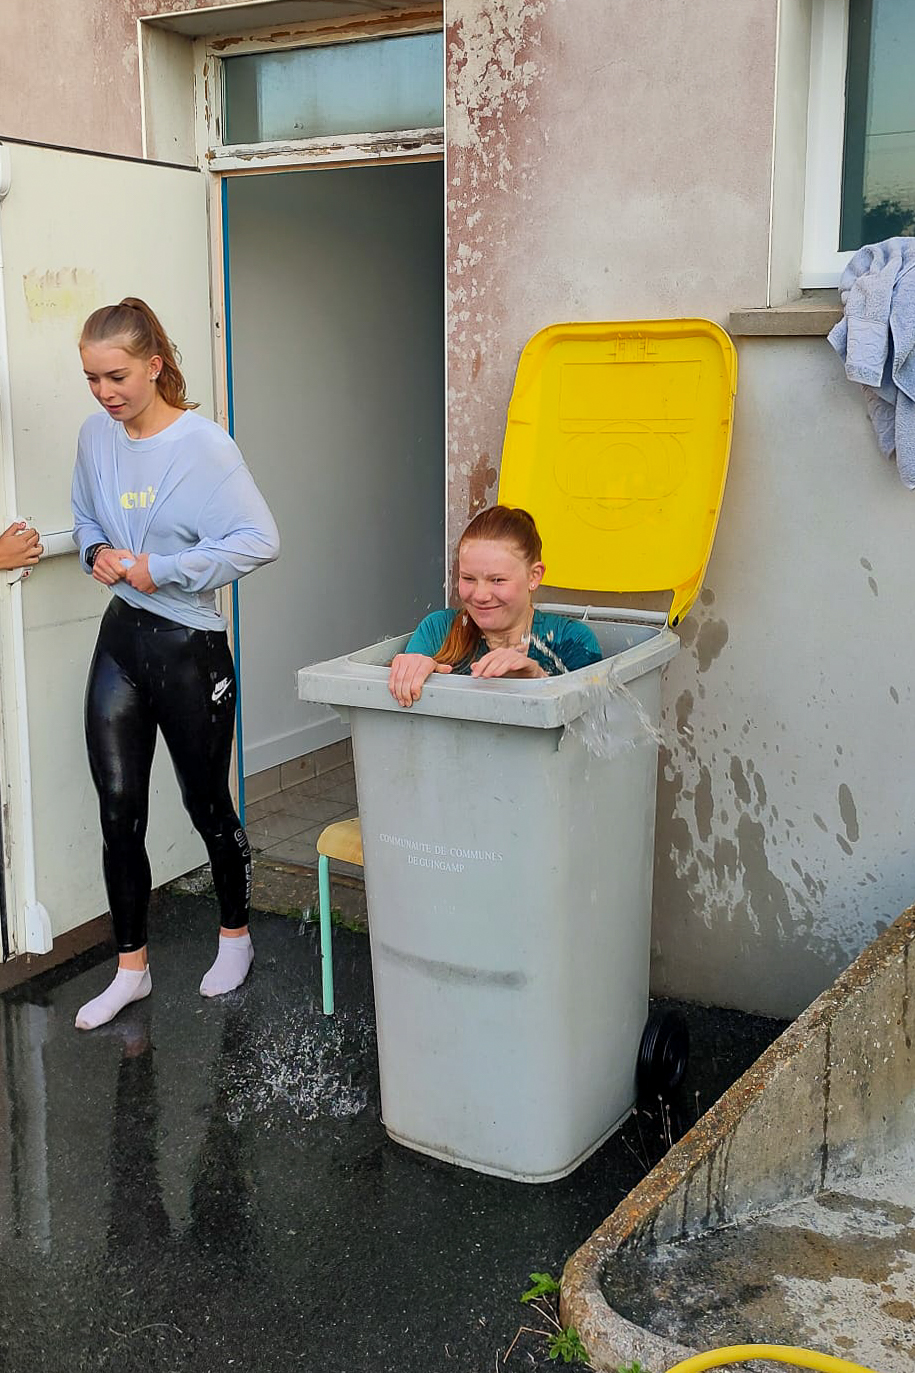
[223,33,444,143]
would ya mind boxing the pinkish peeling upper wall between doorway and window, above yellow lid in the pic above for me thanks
[445,0,776,541]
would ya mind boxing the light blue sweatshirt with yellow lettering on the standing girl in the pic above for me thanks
[73,411,279,629]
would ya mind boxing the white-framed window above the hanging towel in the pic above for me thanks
[801,0,915,287]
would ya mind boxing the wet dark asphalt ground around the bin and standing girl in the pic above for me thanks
[0,892,782,1373]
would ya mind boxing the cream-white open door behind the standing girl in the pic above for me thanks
[0,141,213,954]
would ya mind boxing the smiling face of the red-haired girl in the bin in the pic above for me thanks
[458,538,544,636]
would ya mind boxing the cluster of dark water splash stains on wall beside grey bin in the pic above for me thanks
[653,588,860,1015]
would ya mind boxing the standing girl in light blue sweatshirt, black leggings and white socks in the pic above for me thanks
[73,297,279,1030]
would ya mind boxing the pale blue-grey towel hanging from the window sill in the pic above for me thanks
[828,238,915,490]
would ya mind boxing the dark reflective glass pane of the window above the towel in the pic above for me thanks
[839,0,915,251]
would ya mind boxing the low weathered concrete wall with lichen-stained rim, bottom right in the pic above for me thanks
[561,906,915,1373]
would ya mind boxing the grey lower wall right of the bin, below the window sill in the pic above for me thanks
[653,339,915,1015]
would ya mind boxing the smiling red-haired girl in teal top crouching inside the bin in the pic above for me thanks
[387,505,600,707]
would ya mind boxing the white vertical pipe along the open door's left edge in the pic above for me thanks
[0,144,52,953]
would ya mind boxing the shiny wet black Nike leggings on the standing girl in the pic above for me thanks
[85,596,251,953]
